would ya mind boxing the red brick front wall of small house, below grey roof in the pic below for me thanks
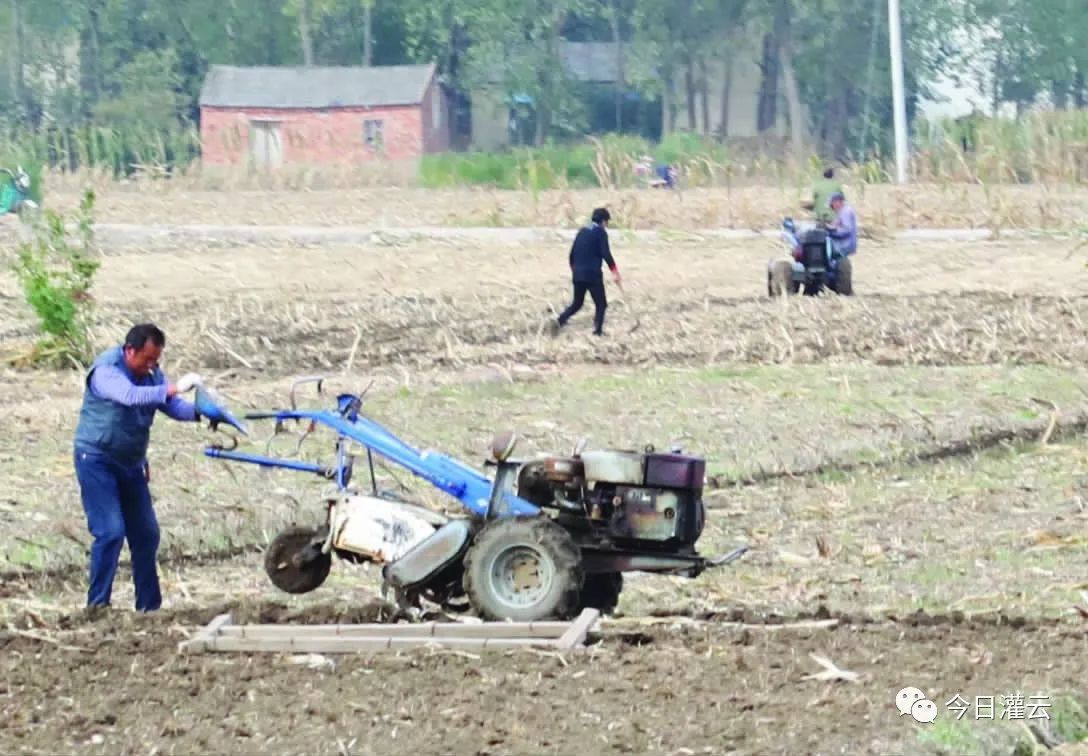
[200,106,428,165]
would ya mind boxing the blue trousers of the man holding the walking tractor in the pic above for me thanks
[75,449,162,611]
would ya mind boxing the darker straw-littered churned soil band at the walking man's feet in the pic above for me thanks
[44,293,1088,377]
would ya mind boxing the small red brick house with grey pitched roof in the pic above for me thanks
[199,63,449,166]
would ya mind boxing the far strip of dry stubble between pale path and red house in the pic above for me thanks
[40,176,1088,231]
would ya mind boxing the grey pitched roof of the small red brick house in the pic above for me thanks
[200,63,435,108]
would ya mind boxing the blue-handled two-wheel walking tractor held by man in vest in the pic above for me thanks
[202,376,747,622]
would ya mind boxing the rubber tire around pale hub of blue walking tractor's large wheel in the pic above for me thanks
[462,517,585,622]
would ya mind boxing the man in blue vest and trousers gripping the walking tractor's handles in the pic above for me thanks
[74,323,200,611]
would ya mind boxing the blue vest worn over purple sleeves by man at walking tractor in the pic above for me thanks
[75,347,163,464]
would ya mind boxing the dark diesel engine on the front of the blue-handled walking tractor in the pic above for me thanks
[518,450,706,551]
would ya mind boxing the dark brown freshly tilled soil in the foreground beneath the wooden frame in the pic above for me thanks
[0,607,1088,756]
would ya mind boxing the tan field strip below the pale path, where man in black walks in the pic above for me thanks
[6,230,1088,376]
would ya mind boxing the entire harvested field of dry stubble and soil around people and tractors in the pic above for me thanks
[0,187,1088,755]
